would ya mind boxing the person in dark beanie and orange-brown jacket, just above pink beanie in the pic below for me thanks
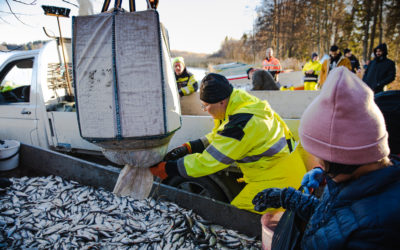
[319,45,351,88]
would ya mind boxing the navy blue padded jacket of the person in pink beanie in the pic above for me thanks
[282,159,400,249]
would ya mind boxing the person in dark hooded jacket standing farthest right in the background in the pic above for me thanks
[363,43,396,94]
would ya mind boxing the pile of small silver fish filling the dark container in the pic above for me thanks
[0,176,261,249]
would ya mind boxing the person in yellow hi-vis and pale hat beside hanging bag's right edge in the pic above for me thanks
[172,57,199,96]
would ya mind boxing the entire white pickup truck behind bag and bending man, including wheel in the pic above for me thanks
[0,40,318,201]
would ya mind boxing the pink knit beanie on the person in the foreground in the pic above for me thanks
[299,67,389,165]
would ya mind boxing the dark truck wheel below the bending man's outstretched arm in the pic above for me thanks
[164,176,229,202]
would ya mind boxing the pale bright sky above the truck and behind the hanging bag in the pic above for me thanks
[0,0,260,53]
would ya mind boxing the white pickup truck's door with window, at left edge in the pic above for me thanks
[0,57,38,145]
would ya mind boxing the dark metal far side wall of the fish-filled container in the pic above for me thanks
[0,144,261,237]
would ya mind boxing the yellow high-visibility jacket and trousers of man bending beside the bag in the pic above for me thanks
[177,89,305,212]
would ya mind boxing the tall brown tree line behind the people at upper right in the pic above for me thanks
[213,0,400,63]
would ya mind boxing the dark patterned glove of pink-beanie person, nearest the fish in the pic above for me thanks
[253,188,286,212]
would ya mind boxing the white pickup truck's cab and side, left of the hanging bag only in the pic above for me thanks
[0,40,101,153]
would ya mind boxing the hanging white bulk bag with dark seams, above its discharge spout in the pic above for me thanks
[73,10,181,165]
